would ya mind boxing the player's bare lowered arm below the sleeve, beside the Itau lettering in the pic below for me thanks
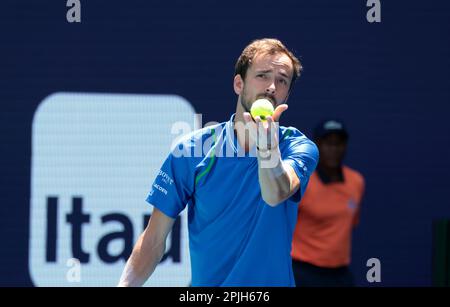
[118,207,175,287]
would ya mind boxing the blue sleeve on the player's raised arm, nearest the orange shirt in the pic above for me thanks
[280,128,319,204]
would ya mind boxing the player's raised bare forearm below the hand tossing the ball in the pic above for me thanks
[257,147,293,206]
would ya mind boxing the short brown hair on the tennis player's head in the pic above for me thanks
[234,38,303,87]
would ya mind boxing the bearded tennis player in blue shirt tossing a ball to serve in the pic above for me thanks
[119,39,319,286]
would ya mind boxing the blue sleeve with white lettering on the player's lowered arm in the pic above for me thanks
[146,145,194,218]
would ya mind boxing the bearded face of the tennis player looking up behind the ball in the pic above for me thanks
[238,53,294,112]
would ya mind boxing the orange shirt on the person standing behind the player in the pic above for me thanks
[292,166,364,268]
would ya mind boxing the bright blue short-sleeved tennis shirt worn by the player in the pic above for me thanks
[147,114,319,286]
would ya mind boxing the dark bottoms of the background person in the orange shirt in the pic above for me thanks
[292,260,355,287]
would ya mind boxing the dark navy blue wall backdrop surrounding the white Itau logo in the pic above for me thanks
[0,0,450,286]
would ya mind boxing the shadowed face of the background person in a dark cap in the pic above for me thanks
[317,133,347,168]
